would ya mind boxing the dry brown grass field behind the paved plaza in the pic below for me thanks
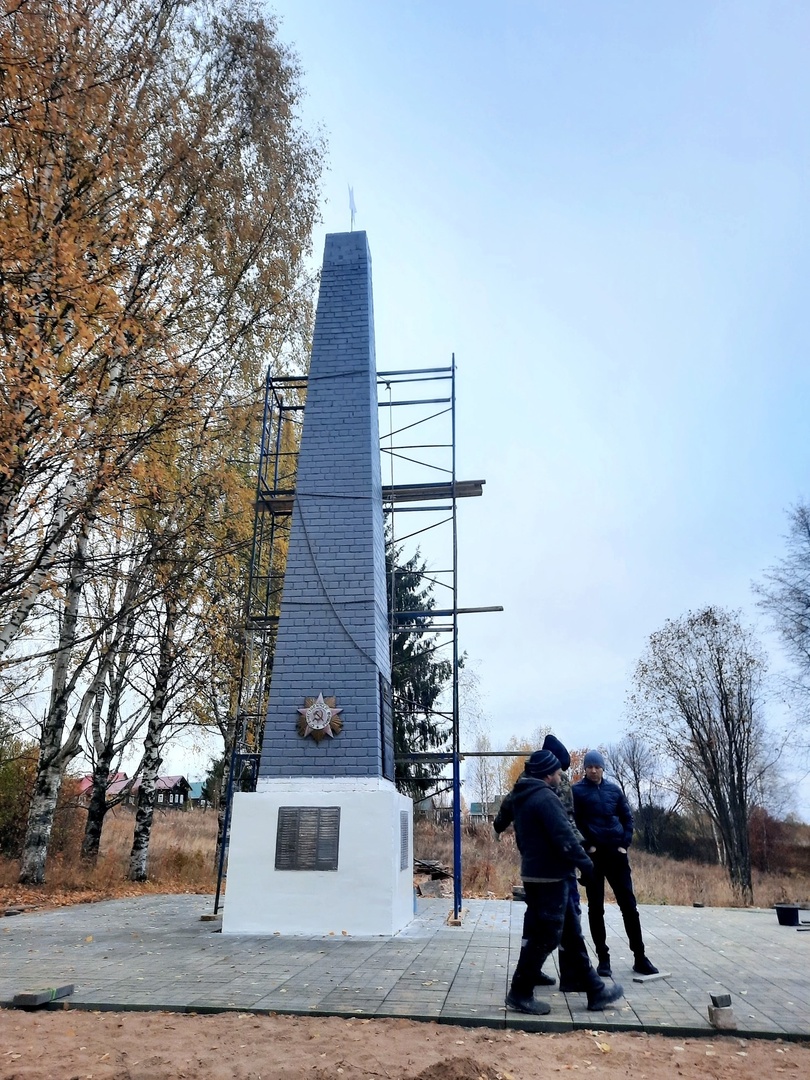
[0,809,810,907]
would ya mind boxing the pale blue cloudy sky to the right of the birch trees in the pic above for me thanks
[213,0,810,803]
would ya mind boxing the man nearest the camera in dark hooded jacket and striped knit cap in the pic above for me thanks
[507,750,622,1016]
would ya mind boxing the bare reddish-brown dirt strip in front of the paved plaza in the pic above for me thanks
[0,1010,810,1080]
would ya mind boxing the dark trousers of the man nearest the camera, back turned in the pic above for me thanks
[512,878,605,998]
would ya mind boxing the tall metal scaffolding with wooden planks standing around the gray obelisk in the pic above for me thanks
[214,356,502,921]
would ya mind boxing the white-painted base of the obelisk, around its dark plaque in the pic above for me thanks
[222,777,414,937]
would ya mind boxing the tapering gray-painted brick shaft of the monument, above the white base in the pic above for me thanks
[259,232,393,779]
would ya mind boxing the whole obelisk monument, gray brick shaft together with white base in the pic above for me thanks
[222,232,413,934]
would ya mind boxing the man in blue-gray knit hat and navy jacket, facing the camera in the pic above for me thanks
[571,750,658,978]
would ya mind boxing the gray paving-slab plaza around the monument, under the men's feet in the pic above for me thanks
[0,895,810,1038]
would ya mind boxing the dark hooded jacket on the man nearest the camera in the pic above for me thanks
[510,773,593,881]
